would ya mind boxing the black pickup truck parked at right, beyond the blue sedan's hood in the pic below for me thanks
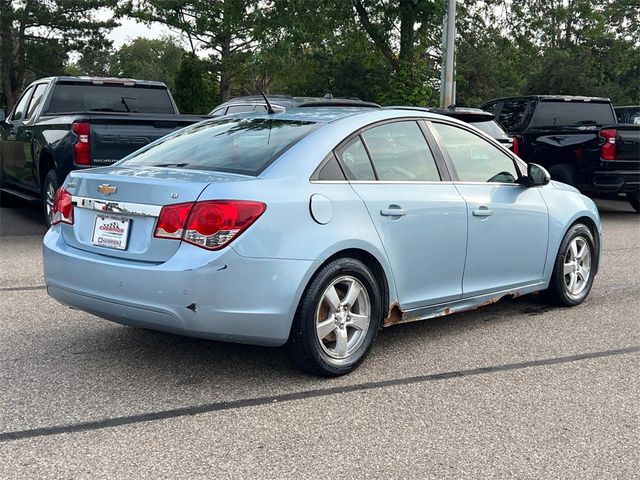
[481,95,640,212]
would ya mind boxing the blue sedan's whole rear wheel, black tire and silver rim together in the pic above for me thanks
[286,258,382,377]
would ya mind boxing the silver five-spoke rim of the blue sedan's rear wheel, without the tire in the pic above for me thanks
[315,275,371,359]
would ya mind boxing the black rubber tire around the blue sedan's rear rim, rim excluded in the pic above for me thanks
[288,258,383,377]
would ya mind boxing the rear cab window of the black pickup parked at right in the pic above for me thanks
[531,102,615,127]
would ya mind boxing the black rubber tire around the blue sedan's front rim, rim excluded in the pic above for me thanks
[550,223,599,307]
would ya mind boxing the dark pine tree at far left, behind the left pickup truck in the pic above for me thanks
[0,0,116,110]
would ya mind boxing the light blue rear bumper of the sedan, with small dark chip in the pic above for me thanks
[44,227,315,346]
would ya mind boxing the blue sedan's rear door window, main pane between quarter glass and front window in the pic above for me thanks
[362,121,440,182]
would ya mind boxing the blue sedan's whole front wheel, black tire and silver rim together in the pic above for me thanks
[547,223,598,307]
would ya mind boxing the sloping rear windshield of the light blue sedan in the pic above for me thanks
[119,118,319,175]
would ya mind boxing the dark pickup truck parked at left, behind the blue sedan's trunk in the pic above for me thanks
[0,77,206,224]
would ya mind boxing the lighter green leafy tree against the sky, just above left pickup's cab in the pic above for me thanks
[111,36,186,91]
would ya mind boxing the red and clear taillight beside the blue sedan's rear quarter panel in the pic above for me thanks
[154,200,267,250]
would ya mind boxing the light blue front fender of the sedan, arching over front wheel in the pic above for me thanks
[540,182,603,282]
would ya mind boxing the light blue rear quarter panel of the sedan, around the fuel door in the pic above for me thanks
[200,172,397,318]
